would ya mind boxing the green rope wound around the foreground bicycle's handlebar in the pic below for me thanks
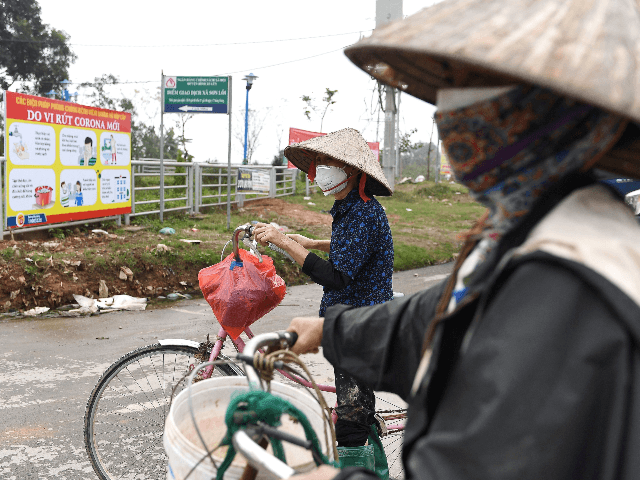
[216,390,337,480]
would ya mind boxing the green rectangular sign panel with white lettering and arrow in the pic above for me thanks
[162,75,229,113]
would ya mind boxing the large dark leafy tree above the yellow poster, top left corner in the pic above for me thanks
[0,0,76,154]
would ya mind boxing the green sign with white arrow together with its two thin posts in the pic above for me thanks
[160,72,231,228]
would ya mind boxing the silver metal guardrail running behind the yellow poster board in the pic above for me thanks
[0,157,298,238]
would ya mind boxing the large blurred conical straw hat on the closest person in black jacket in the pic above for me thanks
[345,0,640,178]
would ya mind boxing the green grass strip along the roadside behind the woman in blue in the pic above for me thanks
[17,180,484,292]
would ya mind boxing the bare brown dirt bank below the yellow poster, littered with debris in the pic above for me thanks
[0,233,188,311]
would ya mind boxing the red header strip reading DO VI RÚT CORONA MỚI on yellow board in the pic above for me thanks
[6,92,131,133]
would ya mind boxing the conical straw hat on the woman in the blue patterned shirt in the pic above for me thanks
[284,128,393,196]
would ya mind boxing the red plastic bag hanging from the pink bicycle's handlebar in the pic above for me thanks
[198,249,287,340]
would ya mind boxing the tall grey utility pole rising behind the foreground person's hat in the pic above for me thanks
[376,0,402,189]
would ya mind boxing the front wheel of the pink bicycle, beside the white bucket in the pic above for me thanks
[84,344,244,480]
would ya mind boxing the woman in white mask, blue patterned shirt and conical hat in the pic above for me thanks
[255,128,393,464]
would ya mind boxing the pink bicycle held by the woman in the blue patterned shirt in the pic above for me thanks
[84,225,406,480]
